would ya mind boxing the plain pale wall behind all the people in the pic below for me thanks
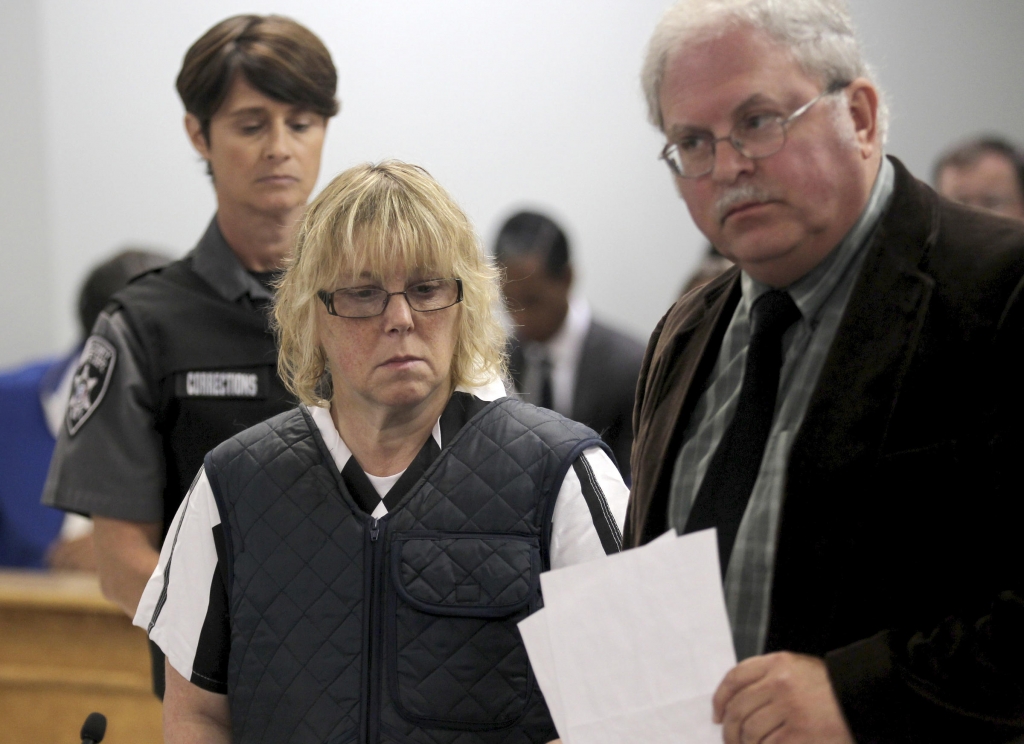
[0,0,1024,364]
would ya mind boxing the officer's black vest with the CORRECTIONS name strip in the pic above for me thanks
[114,258,295,530]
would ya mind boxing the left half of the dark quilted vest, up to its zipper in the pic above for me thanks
[217,411,366,742]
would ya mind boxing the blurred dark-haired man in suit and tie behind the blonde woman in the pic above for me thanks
[495,212,643,476]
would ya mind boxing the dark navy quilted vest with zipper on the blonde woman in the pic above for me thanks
[206,398,603,744]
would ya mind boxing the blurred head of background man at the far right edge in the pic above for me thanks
[933,137,1024,220]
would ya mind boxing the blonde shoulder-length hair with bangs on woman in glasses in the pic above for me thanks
[273,160,507,405]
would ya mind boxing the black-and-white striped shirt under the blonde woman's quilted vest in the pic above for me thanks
[134,386,629,694]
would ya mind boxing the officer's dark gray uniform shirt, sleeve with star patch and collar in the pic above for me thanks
[43,217,273,522]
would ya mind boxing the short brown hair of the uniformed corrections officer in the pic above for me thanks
[176,15,338,141]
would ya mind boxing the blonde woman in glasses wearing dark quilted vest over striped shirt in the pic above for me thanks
[135,162,628,744]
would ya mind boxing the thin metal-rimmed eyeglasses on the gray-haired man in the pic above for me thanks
[659,82,849,178]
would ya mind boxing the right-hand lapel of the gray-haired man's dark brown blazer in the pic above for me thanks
[766,160,938,650]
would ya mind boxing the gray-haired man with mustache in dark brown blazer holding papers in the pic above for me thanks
[625,0,1024,744]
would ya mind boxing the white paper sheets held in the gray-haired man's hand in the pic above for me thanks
[520,530,736,744]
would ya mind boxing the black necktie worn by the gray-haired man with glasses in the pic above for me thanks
[684,290,800,577]
